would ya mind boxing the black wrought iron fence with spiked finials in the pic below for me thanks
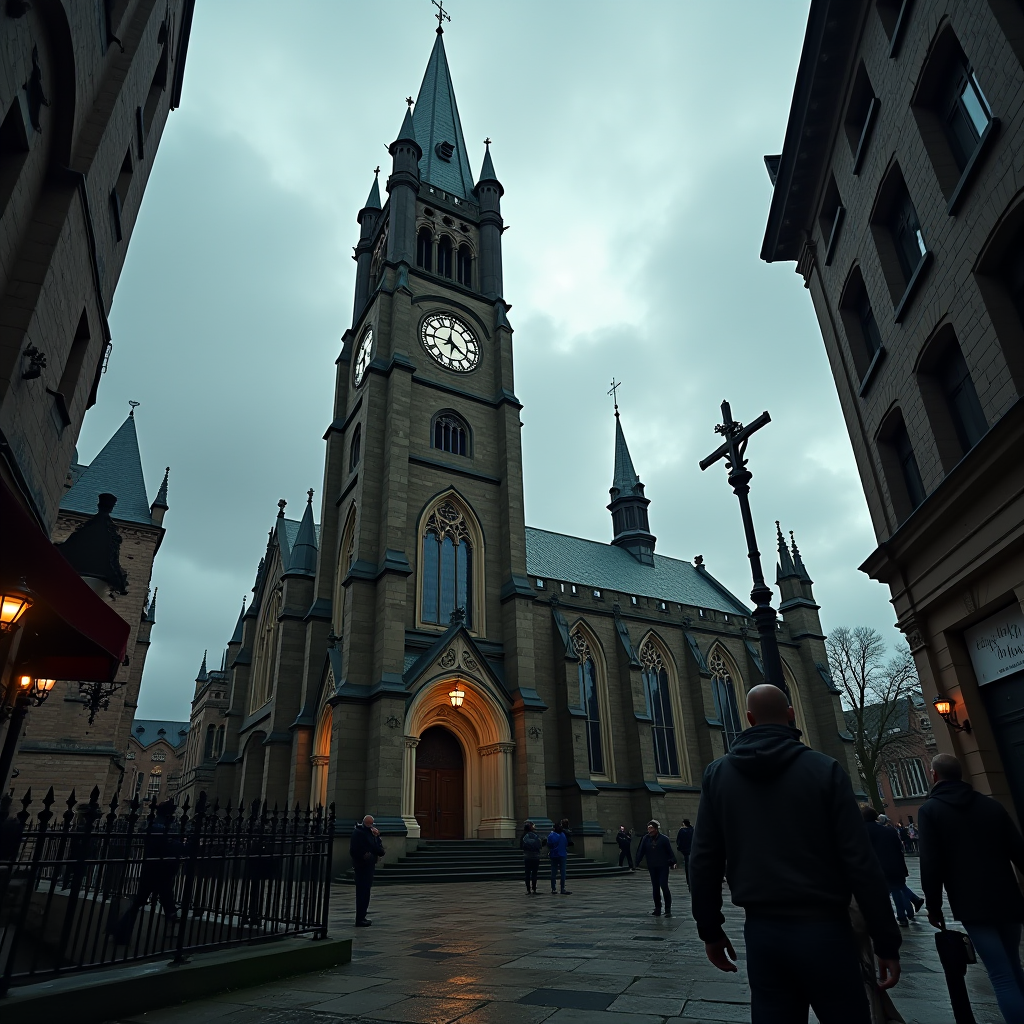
[0,786,334,995]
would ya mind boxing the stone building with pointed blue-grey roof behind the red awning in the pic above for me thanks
[14,410,168,800]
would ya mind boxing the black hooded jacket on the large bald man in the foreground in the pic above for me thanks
[690,725,901,957]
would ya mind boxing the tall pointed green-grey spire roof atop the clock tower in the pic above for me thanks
[413,34,473,200]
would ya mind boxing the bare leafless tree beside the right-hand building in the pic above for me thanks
[825,626,921,811]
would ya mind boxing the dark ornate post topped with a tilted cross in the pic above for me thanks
[700,401,788,693]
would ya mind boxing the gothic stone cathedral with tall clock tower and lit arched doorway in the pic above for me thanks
[181,30,857,859]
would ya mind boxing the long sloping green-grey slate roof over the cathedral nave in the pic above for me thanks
[526,526,751,615]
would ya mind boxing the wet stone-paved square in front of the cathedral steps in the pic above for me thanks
[110,863,1002,1024]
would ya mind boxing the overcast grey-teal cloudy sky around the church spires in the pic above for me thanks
[79,0,898,719]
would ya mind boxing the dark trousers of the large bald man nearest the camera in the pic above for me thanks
[743,915,870,1024]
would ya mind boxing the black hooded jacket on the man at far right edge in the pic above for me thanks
[918,782,1024,925]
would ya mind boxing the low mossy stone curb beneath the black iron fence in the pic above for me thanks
[0,938,352,1024]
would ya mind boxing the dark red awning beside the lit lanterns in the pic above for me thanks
[0,479,130,682]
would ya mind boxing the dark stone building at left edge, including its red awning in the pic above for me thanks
[0,0,194,787]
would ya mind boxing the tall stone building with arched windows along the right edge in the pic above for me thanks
[762,0,1024,819]
